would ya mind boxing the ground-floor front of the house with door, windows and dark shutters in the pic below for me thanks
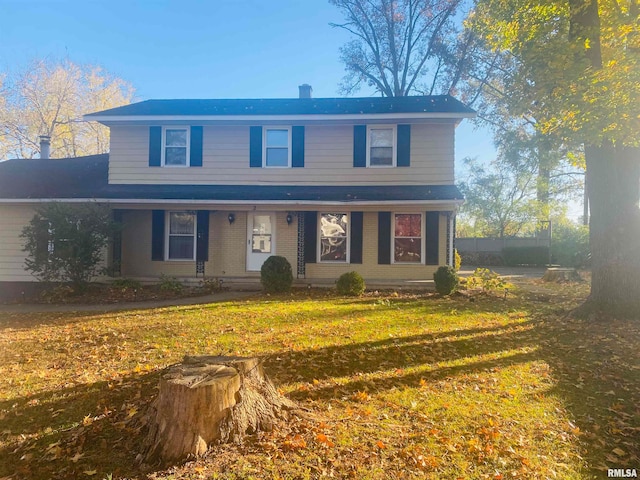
[109,206,455,289]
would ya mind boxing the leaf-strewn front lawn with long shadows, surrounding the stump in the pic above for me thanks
[0,284,640,479]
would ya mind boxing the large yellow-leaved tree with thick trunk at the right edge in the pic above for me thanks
[473,0,640,316]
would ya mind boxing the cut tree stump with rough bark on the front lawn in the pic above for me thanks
[138,356,295,464]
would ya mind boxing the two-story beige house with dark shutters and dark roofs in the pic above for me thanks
[0,85,474,296]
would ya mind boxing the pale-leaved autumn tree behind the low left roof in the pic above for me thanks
[0,59,133,159]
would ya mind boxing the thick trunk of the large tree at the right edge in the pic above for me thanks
[585,146,640,317]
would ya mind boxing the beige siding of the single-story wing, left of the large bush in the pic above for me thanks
[0,205,37,282]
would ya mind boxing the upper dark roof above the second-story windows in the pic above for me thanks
[86,95,475,119]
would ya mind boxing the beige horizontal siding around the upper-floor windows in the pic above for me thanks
[109,123,454,185]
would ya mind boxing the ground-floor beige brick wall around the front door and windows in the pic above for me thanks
[122,208,447,280]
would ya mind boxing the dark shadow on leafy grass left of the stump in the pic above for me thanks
[0,372,161,480]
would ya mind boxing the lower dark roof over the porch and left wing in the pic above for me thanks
[0,154,462,202]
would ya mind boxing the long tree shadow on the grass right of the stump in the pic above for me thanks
[266,312,640,477]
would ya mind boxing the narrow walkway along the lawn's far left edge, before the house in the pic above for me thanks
[0,291,256,314]
